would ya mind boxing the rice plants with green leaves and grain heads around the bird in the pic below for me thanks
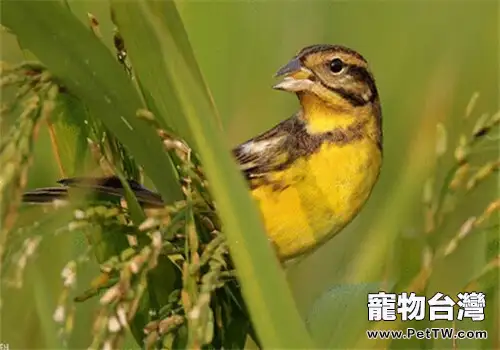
[0,1,500,349]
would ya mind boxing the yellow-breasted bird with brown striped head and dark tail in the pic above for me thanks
[23,44,383,261]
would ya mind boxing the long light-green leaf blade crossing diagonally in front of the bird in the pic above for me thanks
[112,1,313,348]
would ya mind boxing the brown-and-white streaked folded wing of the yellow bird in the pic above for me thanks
[233,117,299,180]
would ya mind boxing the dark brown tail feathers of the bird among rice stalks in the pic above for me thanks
[23,176,164,207]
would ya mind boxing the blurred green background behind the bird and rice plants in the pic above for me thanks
[1,0,500,348]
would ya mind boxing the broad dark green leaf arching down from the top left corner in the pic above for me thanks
[1,0,181,201]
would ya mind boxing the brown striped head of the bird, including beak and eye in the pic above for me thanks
[274,45,378,109]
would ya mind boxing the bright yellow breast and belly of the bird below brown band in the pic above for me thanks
[252,138,381,258]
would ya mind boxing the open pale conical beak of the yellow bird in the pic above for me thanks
[273,58,313,92]
